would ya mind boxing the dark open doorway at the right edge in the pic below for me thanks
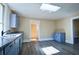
[73,18,79,44]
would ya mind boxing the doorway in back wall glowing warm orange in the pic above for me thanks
[30,20,40,41]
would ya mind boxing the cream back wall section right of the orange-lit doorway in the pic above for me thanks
[40,20,55,41]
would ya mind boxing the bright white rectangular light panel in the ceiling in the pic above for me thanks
[40,4,61,12]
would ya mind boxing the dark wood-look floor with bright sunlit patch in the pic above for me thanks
[21,40,79,55]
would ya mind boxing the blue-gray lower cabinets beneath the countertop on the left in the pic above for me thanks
[5,36,22,55]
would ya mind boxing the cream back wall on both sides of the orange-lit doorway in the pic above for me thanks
[19,17,54,42]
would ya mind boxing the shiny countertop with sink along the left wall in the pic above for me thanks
[0,33,22,50]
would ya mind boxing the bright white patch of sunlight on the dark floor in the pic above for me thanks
[41,46,60,55]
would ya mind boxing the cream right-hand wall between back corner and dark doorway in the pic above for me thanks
[55,18,73,44]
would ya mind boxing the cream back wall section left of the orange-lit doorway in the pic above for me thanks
[19,17,30,42]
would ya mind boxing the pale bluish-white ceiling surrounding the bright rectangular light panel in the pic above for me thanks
[8,3,79,20]
